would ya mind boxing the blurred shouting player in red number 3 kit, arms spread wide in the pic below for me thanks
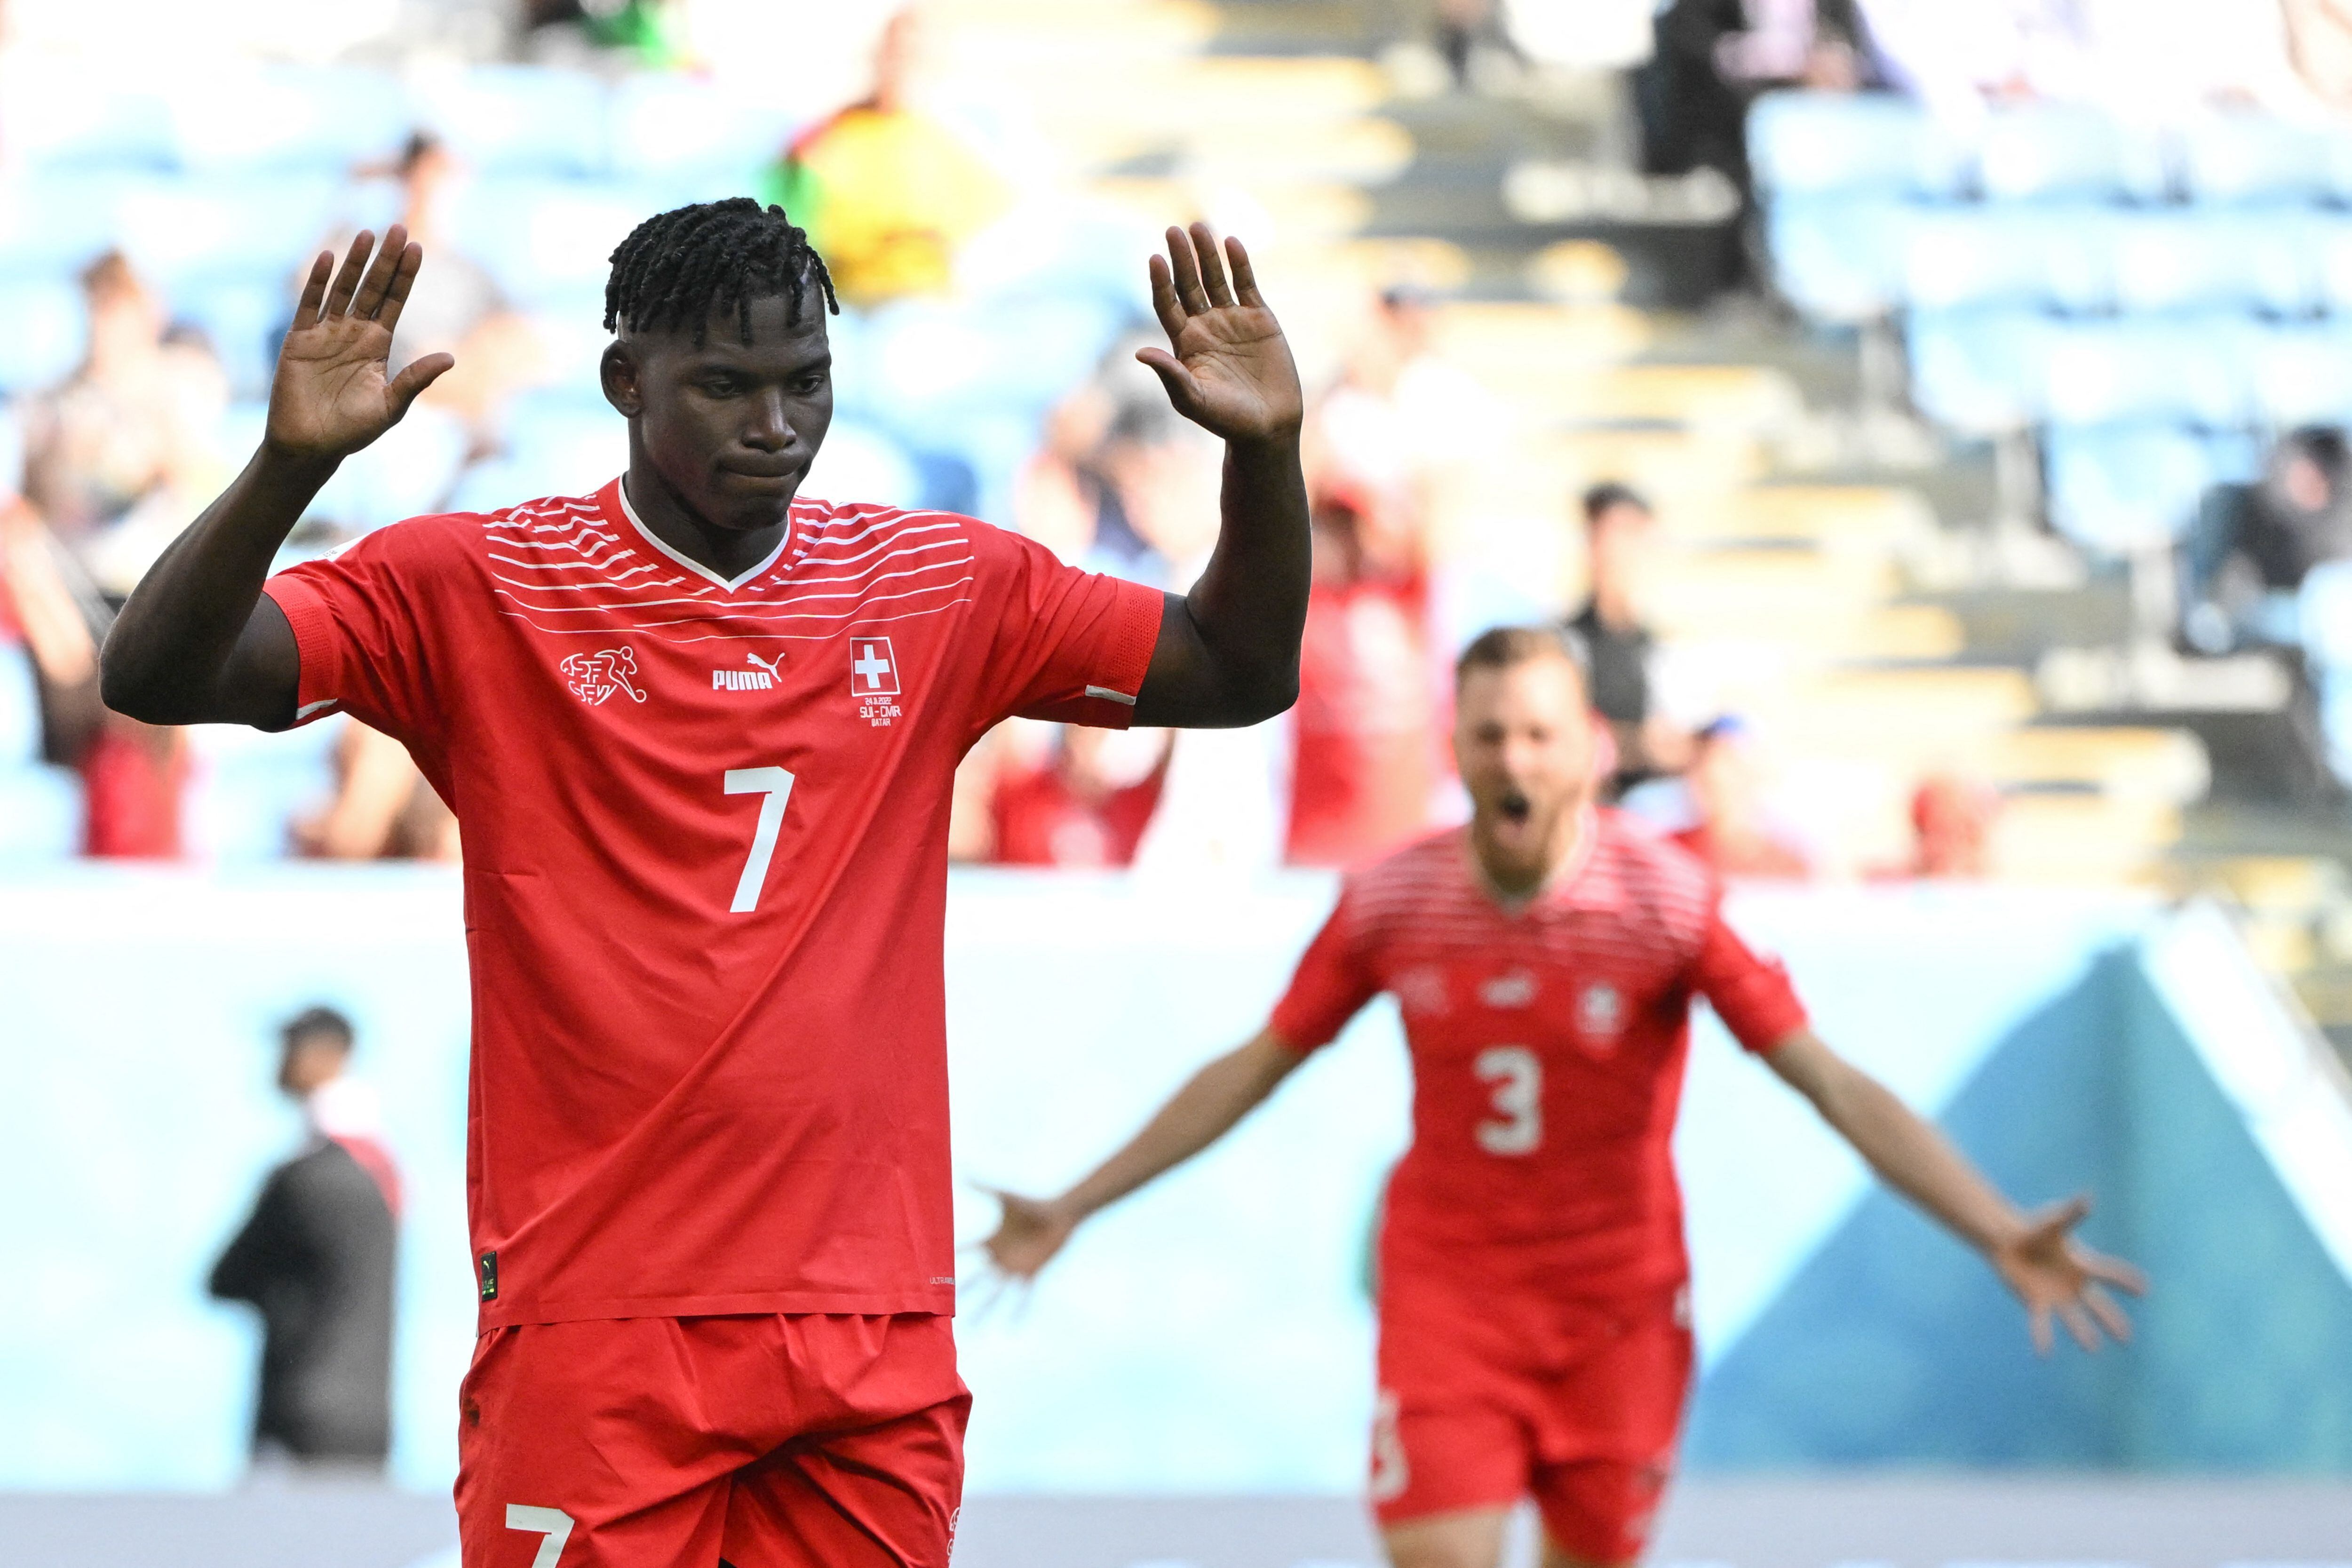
[988,628,2140,1568]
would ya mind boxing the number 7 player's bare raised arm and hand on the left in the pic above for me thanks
[99,226,454,729]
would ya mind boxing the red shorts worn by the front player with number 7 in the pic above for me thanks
[456,1314,971,1568]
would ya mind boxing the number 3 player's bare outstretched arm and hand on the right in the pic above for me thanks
[1764,1030,2145,1352]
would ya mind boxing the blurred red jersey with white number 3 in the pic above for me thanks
[1270,811,1804,1295]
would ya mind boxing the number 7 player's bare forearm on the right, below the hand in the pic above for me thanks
[1185,430,1310,719]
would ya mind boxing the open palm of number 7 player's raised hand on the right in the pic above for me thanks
[1136,223,1305,442]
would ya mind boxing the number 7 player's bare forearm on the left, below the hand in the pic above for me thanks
[99,446,334,724]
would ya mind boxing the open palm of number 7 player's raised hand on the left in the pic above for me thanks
[268,223,456,461]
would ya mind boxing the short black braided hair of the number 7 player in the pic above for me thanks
[604,195,842,348]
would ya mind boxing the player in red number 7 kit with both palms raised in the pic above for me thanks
[103,200,1308,1568]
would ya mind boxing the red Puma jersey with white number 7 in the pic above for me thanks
[268,479,1162,1328]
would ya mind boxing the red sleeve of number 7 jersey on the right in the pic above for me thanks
[971,522,1167,729]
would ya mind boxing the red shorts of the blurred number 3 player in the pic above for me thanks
[1371,1281,1691,1563]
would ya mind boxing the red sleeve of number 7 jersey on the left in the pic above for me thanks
[261,519,449,750]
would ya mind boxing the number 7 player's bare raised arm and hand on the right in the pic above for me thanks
[1136,223,1308,729]
